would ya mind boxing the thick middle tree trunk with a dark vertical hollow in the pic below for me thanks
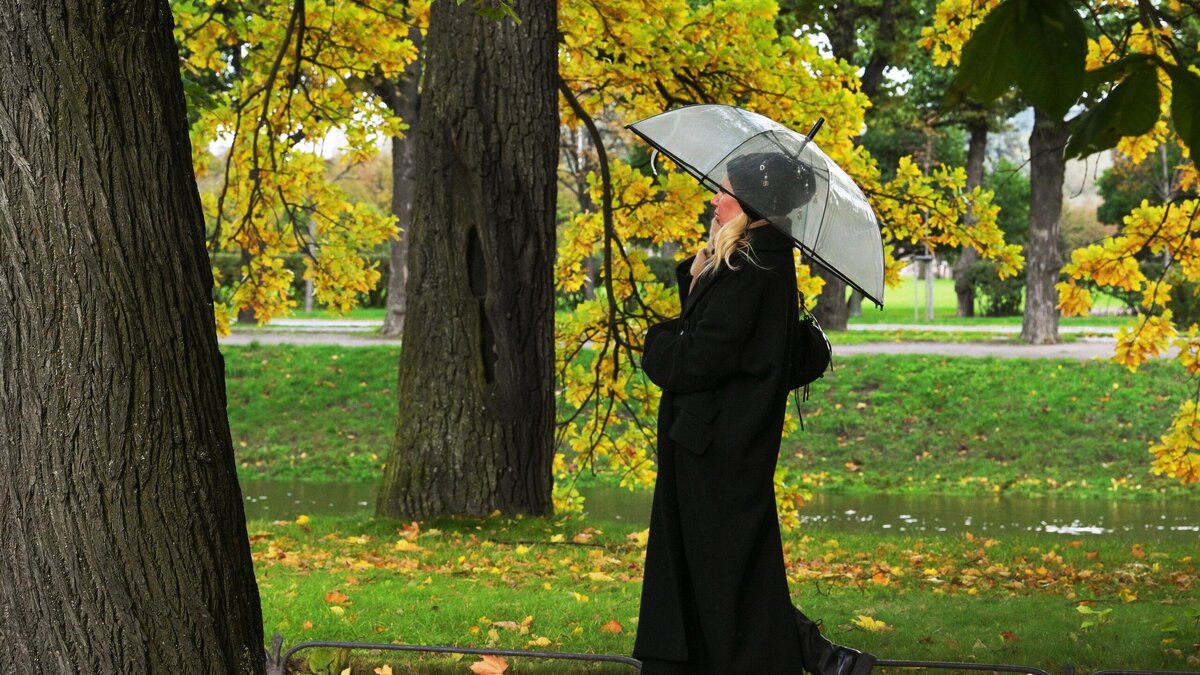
[377,0,558,519]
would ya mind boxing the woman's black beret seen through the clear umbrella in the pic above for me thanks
[725,153,816,217]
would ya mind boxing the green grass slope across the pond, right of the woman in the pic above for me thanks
[782,356,1189,496]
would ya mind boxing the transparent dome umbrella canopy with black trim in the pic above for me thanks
[626,104,883,306]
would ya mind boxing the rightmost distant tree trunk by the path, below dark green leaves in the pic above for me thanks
[1021,109,1069,345]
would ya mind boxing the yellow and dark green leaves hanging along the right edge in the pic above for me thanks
[923,0,1200,483]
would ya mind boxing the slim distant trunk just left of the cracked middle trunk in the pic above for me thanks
[380,28,422,338]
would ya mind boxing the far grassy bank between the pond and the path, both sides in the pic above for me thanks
[223,346,1186,496]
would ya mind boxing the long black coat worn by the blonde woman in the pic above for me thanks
[634,226,800,675]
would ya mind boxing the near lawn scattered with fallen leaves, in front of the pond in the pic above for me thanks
[258,518,1200,673]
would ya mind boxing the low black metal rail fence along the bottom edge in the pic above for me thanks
[266,634,1200,675]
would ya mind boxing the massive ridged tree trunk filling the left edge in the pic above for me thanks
[0,0,265,674]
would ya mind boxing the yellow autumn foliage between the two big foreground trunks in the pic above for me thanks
[172,0,428,333]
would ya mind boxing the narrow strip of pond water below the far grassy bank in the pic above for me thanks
[241,480,1200,545]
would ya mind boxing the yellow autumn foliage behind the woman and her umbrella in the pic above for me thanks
[556,0,1022,511]
